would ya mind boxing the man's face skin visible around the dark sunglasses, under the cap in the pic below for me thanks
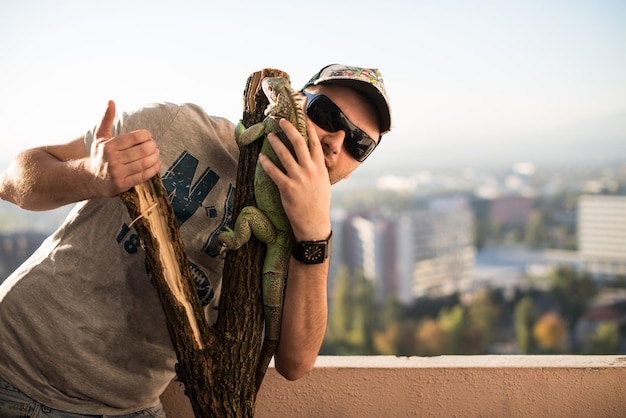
[305,85,380,184]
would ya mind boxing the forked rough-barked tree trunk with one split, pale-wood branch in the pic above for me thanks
[121,69,288,417]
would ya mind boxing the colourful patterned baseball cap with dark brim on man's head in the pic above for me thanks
[302,64,391,134]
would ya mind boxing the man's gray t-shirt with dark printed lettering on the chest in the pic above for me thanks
[0,103,239,414]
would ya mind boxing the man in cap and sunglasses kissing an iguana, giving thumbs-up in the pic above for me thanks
[0,64,391,417]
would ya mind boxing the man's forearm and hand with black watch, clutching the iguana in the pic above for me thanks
[259,119,331,380]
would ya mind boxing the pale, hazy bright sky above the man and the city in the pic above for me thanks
[0,0,626,171]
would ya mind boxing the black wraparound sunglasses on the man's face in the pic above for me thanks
[303,91,382,163]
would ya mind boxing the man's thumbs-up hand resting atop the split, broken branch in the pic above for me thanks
[89,101,161,197]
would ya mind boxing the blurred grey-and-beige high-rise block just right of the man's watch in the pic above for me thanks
[330,196,475,304]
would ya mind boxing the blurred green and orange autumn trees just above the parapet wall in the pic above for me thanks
[321,266,626,356]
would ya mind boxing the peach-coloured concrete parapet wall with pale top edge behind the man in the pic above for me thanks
[162,356,626,418]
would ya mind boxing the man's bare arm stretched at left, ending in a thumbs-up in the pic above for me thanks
[0,101,160,210]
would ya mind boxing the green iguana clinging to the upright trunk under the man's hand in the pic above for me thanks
[218,77,308,391]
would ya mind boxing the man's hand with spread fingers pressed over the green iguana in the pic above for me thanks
[259,119,331,241]
